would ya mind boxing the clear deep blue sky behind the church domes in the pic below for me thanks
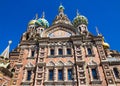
[0,0,120,53]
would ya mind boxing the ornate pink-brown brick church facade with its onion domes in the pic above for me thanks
[10,5,120,86]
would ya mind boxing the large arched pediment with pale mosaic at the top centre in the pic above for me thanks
[41,24,76,38]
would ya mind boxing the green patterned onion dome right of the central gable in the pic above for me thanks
[73,13,88,27]
